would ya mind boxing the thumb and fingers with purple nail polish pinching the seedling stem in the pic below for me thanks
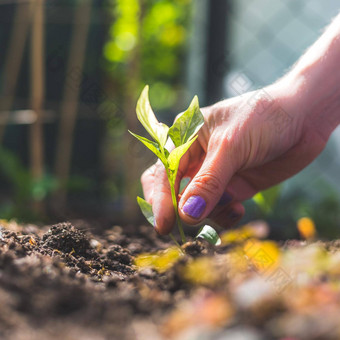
[142,129,239,235]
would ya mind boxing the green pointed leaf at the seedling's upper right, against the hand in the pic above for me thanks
[169,96,204,147]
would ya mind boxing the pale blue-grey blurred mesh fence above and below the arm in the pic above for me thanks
[222,0,340,235]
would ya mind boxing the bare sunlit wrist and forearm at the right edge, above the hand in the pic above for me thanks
[287,15,340,140]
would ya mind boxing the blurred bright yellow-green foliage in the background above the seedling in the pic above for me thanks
[104,0,191,110]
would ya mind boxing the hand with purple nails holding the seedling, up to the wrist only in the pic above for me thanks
[142,77,327,234]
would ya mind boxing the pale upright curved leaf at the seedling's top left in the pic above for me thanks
[136,86,169,147]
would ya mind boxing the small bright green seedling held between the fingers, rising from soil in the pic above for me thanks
[129,86,220,245]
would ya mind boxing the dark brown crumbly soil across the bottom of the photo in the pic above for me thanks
[0,222,340,340]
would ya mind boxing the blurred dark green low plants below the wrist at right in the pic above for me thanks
[250,179,340,239]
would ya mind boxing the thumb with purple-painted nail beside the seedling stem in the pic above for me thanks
[179,145,234,224]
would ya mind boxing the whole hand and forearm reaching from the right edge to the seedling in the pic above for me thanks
[142,14,340,234]
